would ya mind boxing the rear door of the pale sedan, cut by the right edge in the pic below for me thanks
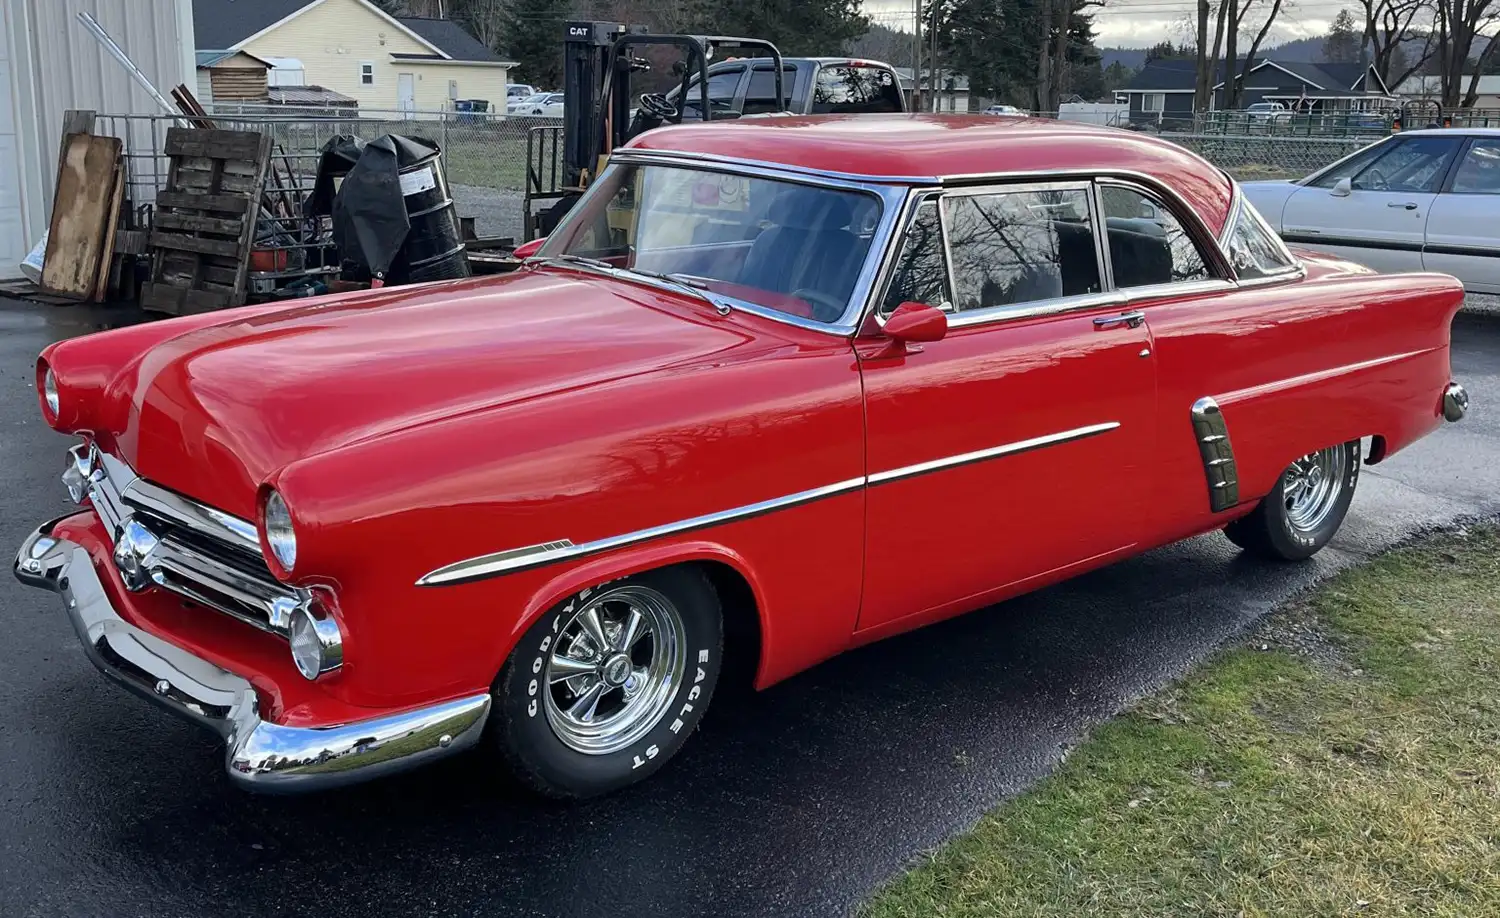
[1422,137,1500,294]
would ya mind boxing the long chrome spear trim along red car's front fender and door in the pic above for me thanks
[417,422,1121,587]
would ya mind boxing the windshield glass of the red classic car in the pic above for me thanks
[539,164,881,323]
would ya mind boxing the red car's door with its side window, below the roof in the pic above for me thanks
[857,182,1155,636]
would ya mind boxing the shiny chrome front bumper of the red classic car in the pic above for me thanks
[15,524,491,794]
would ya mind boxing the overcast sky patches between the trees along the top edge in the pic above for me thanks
[864,0,1358,48]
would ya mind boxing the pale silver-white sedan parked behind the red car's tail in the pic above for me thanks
[1244,128,1500,294]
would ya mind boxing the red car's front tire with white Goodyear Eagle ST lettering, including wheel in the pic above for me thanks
[494,566,723,800]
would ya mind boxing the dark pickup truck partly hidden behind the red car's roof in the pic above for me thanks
[666,57,906,122]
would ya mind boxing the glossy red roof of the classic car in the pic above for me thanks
[629,113,1233,233]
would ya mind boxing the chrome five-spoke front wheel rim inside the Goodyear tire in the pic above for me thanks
[543,584,687,756]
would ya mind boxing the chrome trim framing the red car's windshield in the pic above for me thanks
[564,149,908,338]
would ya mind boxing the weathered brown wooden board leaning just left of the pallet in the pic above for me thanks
[42,134,120,299]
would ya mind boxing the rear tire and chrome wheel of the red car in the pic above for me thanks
[1224,440,1361,561]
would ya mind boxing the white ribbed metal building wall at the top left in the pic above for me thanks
[0,0,197,278]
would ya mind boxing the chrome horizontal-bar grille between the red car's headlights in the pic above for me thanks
[75,447,301,638]
